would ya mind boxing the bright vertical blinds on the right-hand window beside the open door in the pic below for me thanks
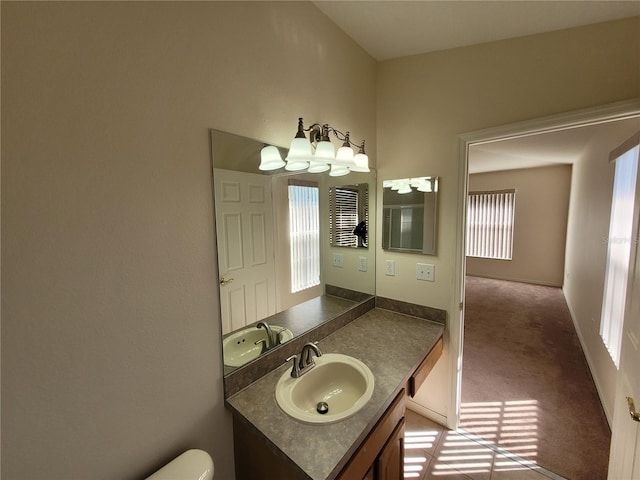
[600,145,640,367]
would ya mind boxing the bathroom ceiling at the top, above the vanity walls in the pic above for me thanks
[313,0,640,60]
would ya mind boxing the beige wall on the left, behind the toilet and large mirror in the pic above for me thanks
[2,2,376,480]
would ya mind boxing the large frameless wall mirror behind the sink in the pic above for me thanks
[210,130,376,375]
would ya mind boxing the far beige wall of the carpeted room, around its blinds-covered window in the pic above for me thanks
[467,165,571,287]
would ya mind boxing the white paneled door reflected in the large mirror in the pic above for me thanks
[213,168,276,334]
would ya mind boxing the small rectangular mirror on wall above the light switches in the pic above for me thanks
[382,177,438,255]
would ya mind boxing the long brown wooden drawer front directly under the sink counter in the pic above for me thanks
[338,388,405,480]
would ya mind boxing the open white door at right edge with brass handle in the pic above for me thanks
[608,139,640,480]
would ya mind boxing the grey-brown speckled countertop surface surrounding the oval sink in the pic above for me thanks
[227,308,444,480]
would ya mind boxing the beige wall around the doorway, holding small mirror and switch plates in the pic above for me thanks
[376,17,640,417]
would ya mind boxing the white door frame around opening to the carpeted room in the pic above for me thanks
[447,98,640,430]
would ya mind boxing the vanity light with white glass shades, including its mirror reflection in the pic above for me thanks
[259,118,370,177]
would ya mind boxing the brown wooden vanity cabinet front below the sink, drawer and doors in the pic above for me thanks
[338,388,406,480]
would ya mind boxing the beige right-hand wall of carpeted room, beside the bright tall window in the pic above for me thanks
[564,119,640,423]
